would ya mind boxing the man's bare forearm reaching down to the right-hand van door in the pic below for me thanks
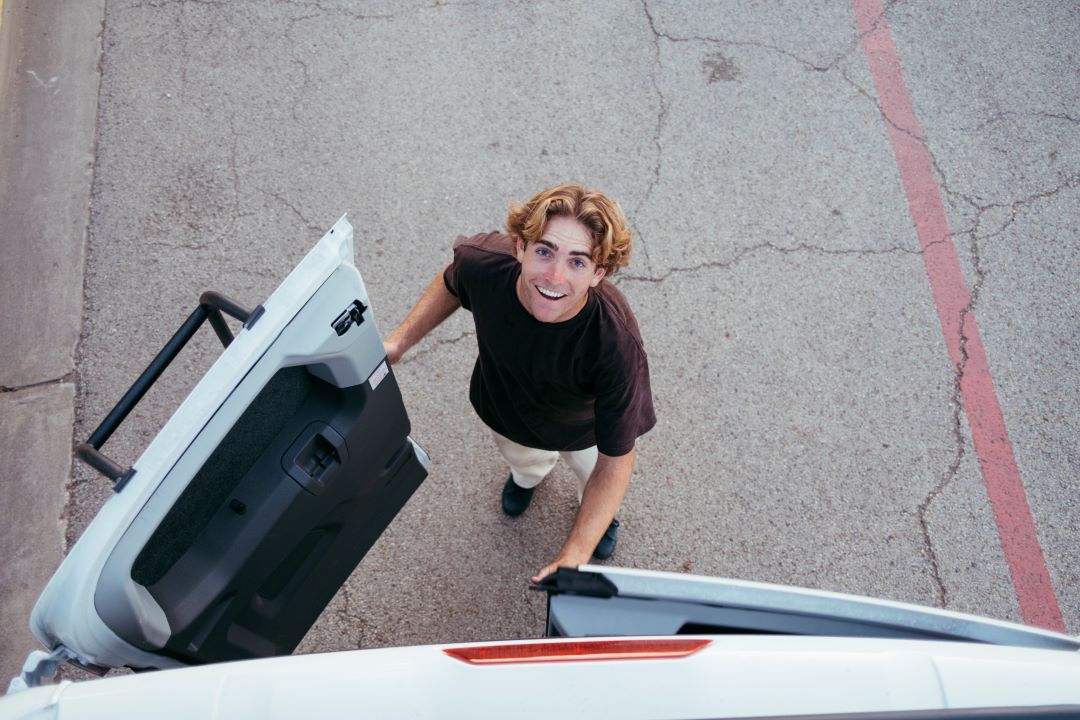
[532,450,635,583]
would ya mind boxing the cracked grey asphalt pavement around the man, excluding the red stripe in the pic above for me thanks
[0,0,1080,677]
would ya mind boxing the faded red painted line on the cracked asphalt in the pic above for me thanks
[852,0,1065,631]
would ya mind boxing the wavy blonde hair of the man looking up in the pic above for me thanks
[507,182,634,275]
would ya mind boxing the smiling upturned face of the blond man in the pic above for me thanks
[516,215,604,323]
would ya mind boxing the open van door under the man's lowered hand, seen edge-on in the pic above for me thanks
[537,566,1080,651]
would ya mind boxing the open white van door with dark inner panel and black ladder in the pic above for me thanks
[30,218,427,668]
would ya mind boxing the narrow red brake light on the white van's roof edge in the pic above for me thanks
[443,638,712,665]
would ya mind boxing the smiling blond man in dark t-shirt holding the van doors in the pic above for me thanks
[384,185,656,582]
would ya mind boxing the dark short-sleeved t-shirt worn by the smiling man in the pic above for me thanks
[443,232,657,457]
